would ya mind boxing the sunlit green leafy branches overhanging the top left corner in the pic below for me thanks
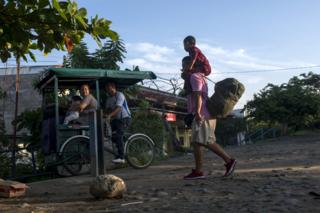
[0,0,117,62]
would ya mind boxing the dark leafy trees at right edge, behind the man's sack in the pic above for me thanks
[245,72,320,130]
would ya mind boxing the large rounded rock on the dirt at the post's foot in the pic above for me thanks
[90,175,127,199]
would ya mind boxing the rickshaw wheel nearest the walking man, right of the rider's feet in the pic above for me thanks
[125,134,155,169]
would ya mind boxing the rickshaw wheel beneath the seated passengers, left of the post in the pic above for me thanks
[60,135,90,175]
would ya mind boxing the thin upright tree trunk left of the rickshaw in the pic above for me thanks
[11,57,20,177]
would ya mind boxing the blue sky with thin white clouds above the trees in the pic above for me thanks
[2,0,320,108]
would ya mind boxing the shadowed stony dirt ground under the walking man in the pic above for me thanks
[0,135,320,213]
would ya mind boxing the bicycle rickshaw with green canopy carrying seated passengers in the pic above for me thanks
[37,68,156,175]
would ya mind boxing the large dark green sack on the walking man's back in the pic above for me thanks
[206,78,245,118]
